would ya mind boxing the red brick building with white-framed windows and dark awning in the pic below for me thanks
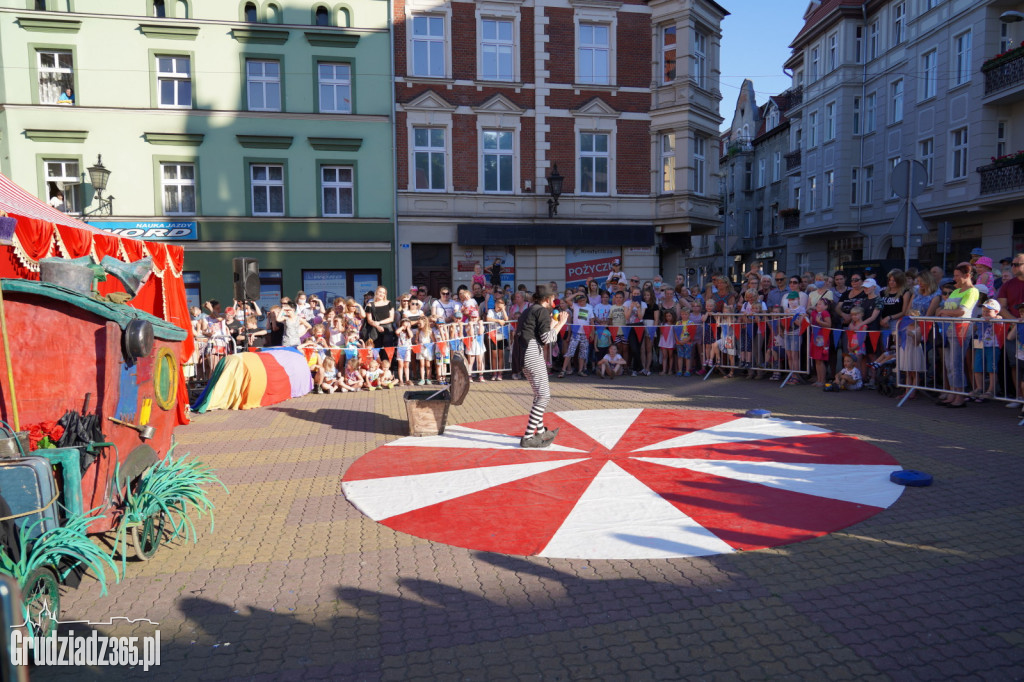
[392,0,726,294]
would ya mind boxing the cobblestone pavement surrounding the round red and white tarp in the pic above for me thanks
[33,377,1024,681]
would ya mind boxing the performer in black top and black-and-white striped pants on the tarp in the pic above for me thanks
[512,286,566,447]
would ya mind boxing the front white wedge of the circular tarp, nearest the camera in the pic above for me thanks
[540,462,733,559]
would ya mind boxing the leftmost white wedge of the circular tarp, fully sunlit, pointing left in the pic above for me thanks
[341,459,583,521]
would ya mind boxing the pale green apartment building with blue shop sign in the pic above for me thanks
[0,0,395,303]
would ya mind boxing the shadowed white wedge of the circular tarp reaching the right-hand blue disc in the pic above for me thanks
[636,457,903,508]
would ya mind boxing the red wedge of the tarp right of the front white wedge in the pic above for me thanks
[621,454,879,550]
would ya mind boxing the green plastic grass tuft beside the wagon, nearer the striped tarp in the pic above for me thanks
[114,444,229,567]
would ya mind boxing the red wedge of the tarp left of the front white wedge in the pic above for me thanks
[386,460,604,555]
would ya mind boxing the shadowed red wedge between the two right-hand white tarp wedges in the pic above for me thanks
[632,433,899,466]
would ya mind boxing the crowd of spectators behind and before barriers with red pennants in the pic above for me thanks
[193,253,1024,413]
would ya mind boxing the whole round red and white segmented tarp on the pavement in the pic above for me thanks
[342,409,903,559]
